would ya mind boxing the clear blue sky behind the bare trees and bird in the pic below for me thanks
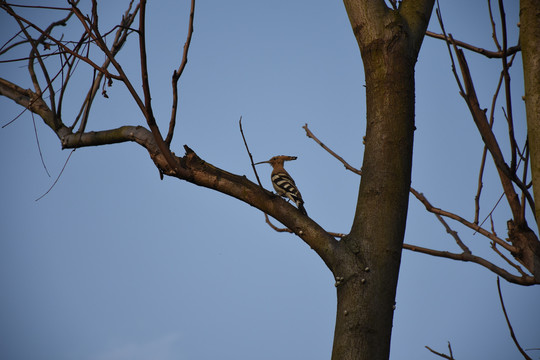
[0,0,540,360]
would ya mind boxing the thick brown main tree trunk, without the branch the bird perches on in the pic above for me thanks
[332,0,433,360]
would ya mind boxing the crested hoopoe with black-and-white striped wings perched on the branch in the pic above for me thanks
[255,155,307,215]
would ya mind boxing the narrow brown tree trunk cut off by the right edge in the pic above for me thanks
[519,0,540,222]
